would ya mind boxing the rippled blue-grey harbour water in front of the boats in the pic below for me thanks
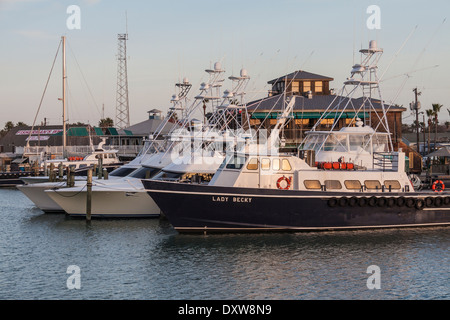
[0,189,450,300]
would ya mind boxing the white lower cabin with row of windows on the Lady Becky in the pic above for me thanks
[209,153,414,193]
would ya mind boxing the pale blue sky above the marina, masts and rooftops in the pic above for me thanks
[0,0,450,128]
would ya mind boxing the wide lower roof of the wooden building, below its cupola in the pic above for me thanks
[247,95,406,113]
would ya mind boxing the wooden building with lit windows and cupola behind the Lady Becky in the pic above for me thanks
[244,70,406,148]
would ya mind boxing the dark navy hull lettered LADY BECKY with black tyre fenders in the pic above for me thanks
[143,180,450,232]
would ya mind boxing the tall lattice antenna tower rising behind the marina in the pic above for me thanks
[116,30,130,129]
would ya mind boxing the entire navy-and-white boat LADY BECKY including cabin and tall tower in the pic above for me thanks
[142,41,450,232]
